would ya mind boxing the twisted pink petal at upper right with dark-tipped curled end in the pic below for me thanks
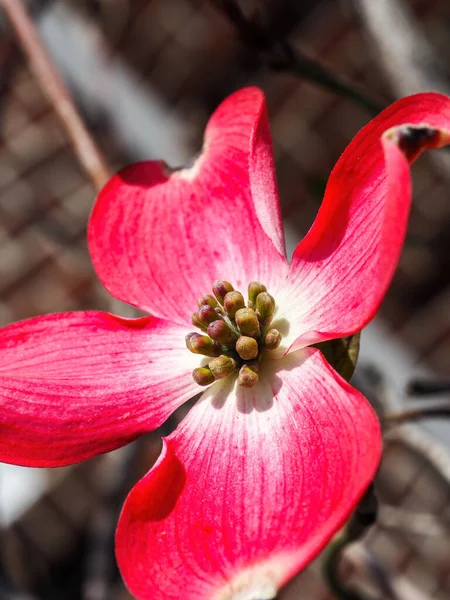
[280,94,450,350]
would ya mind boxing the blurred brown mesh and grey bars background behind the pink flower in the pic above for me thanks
[0,0,450,600]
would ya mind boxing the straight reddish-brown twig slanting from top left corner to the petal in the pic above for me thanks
[0,0,111,189]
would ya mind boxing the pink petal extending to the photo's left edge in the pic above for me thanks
[0,312,199,467]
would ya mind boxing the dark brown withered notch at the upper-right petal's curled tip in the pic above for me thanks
[384,125,450,161]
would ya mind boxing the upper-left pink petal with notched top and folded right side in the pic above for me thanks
[89,88,287,323]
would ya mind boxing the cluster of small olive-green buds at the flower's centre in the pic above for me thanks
[186,281,281,387]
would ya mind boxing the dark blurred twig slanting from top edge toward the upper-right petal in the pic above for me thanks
[211,0,384,114]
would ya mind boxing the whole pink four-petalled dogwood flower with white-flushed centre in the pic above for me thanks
[0,88,450,600]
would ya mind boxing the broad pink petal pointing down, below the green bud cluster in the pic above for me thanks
[116,349,381,600]
